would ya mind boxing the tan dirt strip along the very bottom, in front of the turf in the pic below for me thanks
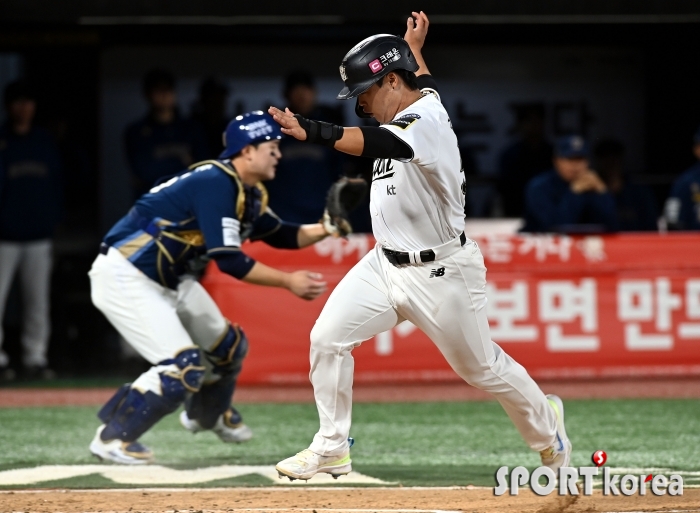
[0,488,700,513]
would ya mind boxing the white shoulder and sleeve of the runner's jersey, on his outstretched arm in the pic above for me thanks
[380,104,440,171]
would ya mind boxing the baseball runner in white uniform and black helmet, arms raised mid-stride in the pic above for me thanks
[269,12,571,479]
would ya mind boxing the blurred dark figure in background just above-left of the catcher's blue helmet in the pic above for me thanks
[192,77,229,155]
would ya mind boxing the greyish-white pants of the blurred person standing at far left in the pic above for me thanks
[0,239,53,367]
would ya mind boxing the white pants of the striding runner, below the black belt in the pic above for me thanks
[309,240,556,456]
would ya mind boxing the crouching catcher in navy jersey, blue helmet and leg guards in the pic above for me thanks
[89,111,367,464]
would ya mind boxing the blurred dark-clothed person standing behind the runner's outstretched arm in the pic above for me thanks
[265,70,344,223]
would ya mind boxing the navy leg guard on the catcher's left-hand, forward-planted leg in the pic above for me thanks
[97,349,204,442]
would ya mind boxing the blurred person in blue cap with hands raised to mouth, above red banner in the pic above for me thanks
[522,135,617,233]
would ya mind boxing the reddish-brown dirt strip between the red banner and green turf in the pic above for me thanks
[0,376,700,408]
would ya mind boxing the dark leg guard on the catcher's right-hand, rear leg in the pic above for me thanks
[185,325,248,429]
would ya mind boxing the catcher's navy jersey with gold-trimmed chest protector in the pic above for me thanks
[104,160,299,289]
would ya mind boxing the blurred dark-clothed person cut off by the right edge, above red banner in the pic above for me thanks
[664,127,700,230]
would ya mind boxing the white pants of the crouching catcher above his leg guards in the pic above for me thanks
[89,248,229,394]
